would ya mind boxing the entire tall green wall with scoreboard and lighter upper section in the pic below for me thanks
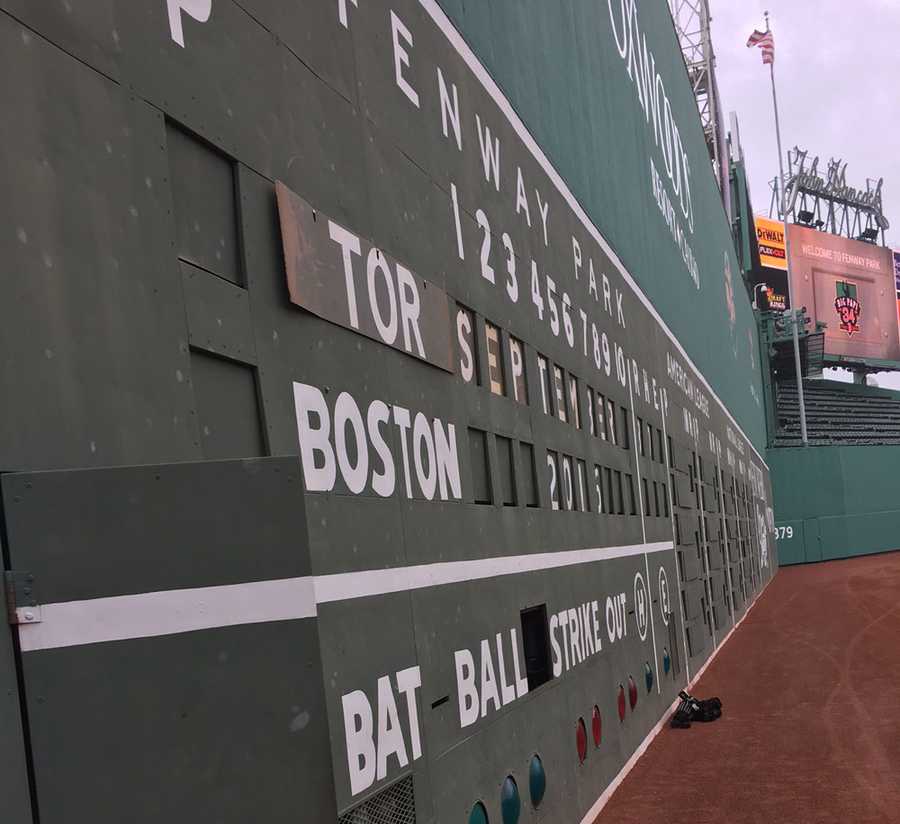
[0,0,777,824]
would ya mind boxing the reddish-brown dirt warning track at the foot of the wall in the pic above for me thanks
[597,552,900,824]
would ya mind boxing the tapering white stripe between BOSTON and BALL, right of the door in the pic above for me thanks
[316,541,673,604]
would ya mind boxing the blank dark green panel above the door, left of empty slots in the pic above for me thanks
[0,16,200,469]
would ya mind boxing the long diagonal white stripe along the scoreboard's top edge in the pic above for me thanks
[419,0,769,469]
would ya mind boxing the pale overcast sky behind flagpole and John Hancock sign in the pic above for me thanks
[710,0,900,389]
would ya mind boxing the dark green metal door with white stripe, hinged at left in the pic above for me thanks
[0,458,336,824]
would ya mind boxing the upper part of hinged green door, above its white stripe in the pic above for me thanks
[2,457,309,603]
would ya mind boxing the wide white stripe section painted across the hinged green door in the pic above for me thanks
[18,577,316,652]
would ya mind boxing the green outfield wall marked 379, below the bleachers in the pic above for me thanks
[766,446,900,564]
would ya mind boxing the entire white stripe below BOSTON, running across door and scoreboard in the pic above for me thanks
[18,541,673,652]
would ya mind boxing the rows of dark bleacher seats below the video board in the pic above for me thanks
[774,380,900,446]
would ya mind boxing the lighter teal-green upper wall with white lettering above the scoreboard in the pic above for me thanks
[440,0,765,449]
